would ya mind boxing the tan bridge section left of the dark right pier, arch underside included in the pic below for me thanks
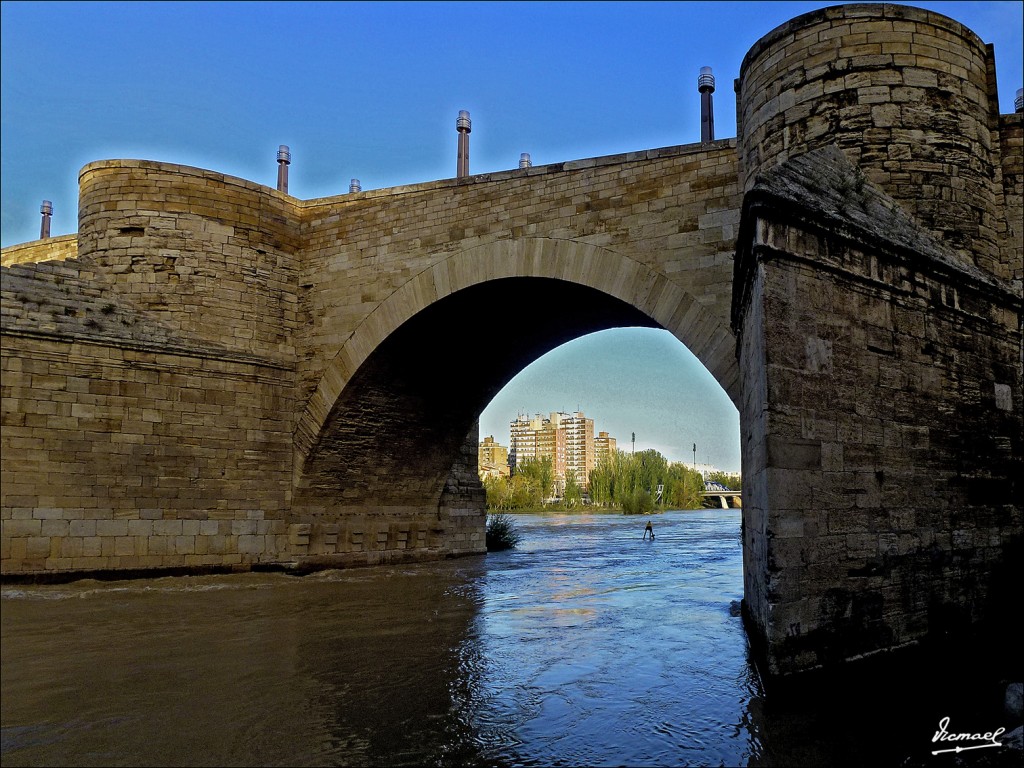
[2,140,739,573]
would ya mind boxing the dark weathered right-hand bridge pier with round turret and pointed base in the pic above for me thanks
[732,5,1024,676]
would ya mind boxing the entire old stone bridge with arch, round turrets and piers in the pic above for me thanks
[2,5,1024,675]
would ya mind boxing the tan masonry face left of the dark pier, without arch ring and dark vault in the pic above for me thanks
[3,141,738,573]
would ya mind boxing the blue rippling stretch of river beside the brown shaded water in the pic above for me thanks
[468,512,756,765]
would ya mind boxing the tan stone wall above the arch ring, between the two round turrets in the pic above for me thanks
[300,140,739,421]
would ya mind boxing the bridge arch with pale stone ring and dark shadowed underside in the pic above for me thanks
[295,239,739,507]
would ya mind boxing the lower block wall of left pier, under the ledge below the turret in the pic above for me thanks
[0,334,293,573]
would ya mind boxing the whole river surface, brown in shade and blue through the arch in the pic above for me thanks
[0,510,1019,767]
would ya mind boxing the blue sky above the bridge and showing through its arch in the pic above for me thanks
[0,2,1024,469]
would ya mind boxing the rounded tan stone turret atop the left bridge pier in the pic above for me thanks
[78,160,300,364]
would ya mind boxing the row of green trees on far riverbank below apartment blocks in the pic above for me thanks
[483,451,739,514]
